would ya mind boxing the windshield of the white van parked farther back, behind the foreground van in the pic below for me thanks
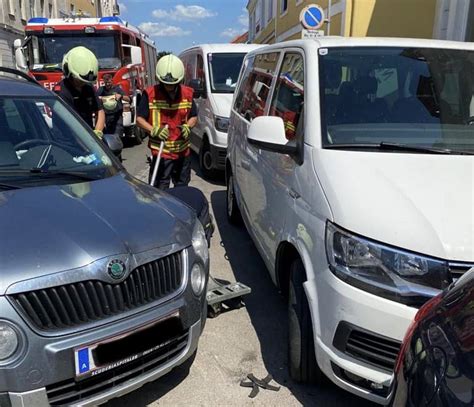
[208,53,245,93]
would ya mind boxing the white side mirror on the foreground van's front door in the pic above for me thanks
[247,116,298,155]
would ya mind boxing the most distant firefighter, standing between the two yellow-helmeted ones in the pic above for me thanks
[97,73,130,137]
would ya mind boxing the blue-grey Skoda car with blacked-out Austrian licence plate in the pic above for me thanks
[0,68,209,406]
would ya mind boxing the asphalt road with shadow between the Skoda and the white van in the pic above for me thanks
[107,143,374,407]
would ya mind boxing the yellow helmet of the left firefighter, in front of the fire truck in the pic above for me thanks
[63,46,99,84]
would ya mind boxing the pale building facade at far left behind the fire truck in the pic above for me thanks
[0,0,97,67]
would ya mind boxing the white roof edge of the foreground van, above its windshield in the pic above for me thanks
[246,36,474,54]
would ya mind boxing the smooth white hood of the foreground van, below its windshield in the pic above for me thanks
[314,149,474,262]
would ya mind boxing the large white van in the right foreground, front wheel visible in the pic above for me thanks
[226,38,474,404]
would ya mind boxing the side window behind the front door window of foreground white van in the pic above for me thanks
[234,52,279,121]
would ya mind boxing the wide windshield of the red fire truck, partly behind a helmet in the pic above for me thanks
[30,33,121,70]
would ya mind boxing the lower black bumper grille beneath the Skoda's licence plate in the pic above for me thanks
[46,333,189,406]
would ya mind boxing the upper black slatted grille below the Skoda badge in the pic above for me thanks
[9,253,183,331]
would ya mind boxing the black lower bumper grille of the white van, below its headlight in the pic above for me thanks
[333,322,401,371]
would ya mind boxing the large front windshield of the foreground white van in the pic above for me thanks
[319,47,474,154]
